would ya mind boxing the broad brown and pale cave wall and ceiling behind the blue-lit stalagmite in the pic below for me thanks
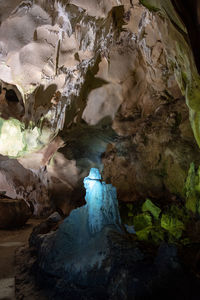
[0,0,200,213]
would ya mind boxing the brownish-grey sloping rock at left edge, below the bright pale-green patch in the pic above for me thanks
[0,155,51,215]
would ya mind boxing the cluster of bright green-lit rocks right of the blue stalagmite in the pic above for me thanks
[123,198,190,245]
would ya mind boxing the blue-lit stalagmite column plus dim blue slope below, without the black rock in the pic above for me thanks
[31,168,122,296]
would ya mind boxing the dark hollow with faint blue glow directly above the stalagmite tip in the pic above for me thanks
[59,117,117,171]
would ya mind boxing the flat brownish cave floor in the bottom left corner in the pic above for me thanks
[0,219,41,300]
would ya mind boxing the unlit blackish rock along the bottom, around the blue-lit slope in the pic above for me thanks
[16,234,199,300]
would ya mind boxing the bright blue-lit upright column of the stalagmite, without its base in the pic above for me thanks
[84,168,121,233]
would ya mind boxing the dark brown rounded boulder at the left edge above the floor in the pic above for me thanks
[0,198,32,229]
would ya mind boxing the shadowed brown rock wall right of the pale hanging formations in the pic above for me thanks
[56,2,199,201]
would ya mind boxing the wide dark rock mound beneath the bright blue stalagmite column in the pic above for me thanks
[16,218,199,300]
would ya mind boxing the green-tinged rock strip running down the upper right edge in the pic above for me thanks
[140,0,200,147]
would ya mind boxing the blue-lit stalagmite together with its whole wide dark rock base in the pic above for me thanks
[16,168,198,300]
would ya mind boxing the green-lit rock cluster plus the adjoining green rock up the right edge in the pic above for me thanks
[122,163,200,245]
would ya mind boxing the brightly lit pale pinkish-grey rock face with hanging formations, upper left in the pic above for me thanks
[0,0,121,156]
